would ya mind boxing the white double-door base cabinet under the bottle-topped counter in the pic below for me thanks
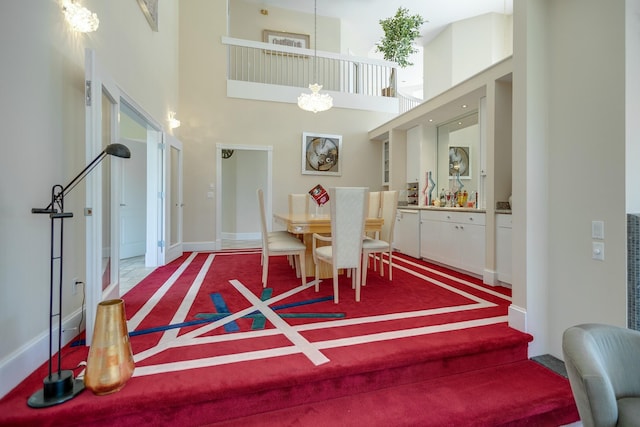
[420,210,485,275]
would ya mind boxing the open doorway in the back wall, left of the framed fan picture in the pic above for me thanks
[218,144,273,249]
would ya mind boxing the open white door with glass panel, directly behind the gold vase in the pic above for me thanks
[85,49,122,345]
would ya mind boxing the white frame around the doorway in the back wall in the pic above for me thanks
[215,143,273,250]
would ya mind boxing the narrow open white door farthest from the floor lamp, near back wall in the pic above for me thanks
[163,134,184,263]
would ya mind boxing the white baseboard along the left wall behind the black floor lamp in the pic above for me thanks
[0,308,86,405]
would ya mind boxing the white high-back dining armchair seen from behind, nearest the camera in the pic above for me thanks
[312,187,368,304]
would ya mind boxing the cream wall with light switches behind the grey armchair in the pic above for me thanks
[513,0,638,357]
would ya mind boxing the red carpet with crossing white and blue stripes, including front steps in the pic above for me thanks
[0,252,577,426]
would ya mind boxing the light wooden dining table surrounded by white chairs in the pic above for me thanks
[273,213,384,279]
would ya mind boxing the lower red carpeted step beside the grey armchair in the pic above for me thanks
[210,361,578,427]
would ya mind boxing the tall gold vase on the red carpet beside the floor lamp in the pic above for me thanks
[84,299,135,395]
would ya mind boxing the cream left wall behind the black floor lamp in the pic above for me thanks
[0,0,178,396]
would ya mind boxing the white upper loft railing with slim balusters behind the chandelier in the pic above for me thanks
[222,37,397,96]
